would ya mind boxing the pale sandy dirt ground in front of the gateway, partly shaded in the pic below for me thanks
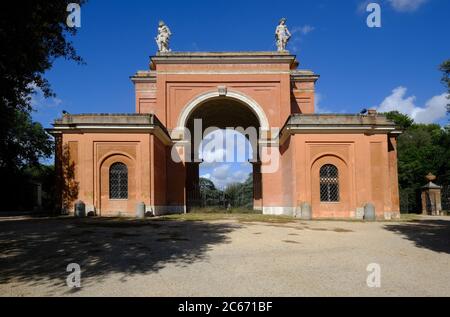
[0,217,450,296]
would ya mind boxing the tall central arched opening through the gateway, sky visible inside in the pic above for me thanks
[186,97,262,211]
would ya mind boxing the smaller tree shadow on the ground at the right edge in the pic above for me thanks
[384,219,450,253]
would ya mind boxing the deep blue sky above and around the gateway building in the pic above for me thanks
[34,0,450,188]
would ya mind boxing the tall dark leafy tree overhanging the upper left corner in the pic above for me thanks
[0,0,85,207]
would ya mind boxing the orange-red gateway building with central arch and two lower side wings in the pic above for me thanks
[50,24,399,218]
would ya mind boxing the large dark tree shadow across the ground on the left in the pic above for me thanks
[0,218,239,286]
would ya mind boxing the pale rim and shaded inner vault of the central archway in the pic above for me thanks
[179,93,267,211]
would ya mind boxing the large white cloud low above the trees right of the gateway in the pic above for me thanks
[377,86,448,123]
